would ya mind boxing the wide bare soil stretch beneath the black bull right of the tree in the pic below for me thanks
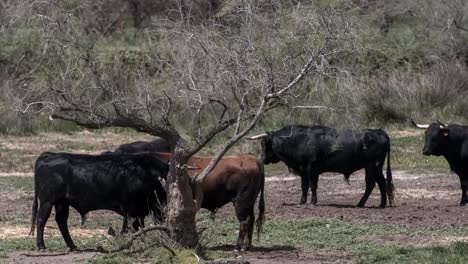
[238,171,468,228]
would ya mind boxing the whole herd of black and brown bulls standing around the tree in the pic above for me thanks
[27,122,468,250]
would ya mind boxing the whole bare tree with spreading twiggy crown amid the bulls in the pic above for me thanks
[6,0,360,247]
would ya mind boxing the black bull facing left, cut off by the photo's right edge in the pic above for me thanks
[411,120,468,205]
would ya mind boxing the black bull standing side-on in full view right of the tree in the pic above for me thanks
[250,125,393,208]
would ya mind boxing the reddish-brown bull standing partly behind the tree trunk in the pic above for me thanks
[158,153,265,250]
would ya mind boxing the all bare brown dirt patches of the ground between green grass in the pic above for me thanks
[0,171,468,264]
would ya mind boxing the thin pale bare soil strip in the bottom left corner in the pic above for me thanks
[6,252,96,264]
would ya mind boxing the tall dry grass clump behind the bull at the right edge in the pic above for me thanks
[361,60,468,123]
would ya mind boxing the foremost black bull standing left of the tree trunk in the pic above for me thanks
[31,152,169,250]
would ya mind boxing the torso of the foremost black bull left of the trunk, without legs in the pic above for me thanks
[35,153,159,213]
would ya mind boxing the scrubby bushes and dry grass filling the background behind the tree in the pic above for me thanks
[0,0,468,134]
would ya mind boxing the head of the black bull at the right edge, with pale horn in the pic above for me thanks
[411,120,449,156]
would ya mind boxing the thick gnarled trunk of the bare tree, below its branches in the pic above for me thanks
[167,145,199,248]
